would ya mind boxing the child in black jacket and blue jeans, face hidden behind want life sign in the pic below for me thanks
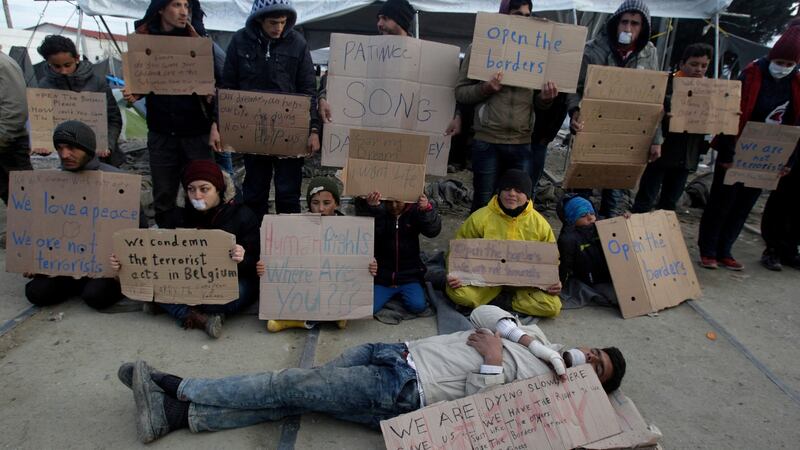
[367,192,442,314]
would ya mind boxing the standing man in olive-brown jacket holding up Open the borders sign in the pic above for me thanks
[456,0,558,212]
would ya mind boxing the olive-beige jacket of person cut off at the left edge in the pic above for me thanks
[0,52,28,150]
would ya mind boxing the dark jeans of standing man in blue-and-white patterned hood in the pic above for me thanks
[242,155,303,220]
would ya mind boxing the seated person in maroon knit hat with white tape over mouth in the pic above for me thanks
[111,160,263,339]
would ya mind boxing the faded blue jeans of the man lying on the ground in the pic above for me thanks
[178,344,420,432]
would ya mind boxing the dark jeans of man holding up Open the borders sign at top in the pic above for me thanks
[472,139,531,212]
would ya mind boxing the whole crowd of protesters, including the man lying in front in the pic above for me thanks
[0,0,800,442]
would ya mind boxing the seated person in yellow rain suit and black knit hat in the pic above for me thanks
[446,169,561,317]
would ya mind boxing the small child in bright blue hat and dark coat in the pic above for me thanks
[558,194,617,306]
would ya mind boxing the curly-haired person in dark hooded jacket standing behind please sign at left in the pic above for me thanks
[36,34,125,167]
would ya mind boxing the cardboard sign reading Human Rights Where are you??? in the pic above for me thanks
[258,214,375,320]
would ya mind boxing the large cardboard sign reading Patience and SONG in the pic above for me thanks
[322,33,460,176]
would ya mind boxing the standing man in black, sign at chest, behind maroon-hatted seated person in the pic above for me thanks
[123,0,220,228]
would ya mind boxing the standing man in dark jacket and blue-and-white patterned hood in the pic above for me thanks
[212,0,320,217]
